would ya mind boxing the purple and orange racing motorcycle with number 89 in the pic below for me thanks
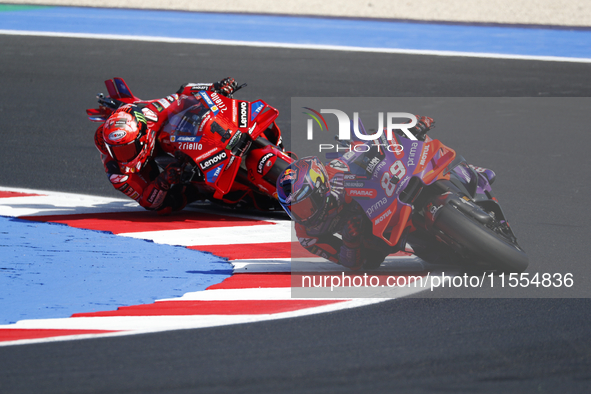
[327,122,529,273]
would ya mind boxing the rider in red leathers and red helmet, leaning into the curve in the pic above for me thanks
[94,78,237,214]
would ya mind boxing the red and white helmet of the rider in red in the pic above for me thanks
[103,104,156,172]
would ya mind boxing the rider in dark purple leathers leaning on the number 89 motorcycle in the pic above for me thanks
[277,117,434,270]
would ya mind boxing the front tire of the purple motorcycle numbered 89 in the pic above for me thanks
[433,204,529,273]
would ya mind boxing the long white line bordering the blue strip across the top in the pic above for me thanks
[0,30,591,63]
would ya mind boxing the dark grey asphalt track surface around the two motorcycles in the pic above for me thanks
[0,36,591,393]
